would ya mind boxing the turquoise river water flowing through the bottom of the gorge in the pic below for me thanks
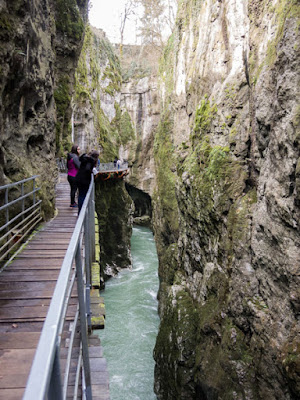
[99,227,159,400]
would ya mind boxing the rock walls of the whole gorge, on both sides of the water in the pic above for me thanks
[0,0,300,400]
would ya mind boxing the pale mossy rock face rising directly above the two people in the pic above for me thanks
[73,26,129,158]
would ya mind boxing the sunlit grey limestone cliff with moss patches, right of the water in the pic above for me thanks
[154,0,300,400]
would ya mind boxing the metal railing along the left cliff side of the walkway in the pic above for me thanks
[0,175,42,262]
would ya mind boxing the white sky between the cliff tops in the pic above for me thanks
[89,0,142,44]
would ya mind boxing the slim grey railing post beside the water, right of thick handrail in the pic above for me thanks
[75,245,92,400]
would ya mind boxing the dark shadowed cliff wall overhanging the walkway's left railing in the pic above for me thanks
[0,0,88,216]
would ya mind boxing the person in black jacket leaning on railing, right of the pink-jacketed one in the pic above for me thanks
[76,150,99,214]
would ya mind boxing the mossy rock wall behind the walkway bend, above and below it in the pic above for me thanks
[72,26,134,282]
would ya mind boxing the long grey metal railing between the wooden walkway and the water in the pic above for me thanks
[23,179,95,400]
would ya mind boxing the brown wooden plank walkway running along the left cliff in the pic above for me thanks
[0,174,109,400]
